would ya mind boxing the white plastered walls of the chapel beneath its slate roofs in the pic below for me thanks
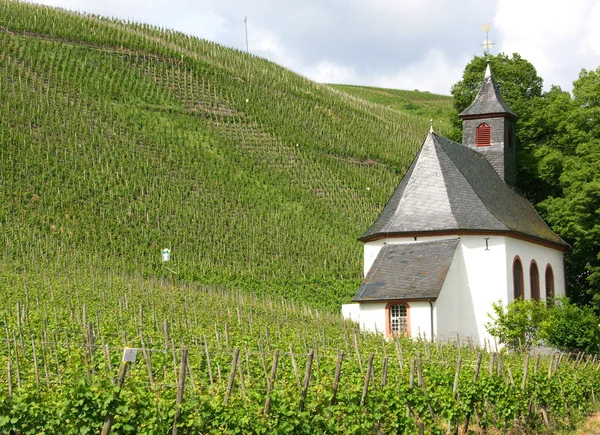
[345,235,565,345]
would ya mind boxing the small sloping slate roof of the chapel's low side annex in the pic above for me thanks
[353,238,458,302]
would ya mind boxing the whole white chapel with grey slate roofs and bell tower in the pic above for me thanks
[342,64,568,344]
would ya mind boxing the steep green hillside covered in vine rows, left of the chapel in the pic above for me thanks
[0,0,450,307]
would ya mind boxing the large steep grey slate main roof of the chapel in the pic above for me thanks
[361,132,568,248]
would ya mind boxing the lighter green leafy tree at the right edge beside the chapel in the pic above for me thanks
[538,68,600,306]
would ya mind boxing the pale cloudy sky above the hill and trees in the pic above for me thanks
[30,0,600,95]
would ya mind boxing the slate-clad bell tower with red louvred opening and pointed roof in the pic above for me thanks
[458,61,518,186]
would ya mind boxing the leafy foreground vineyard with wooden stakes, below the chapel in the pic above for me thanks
[0,271,600,434]
